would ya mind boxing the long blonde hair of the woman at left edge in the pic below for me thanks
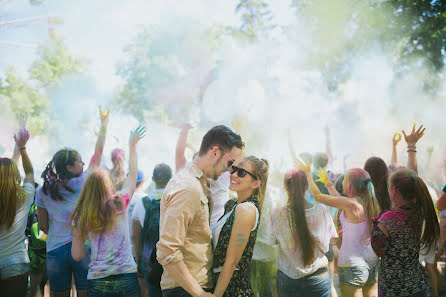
[0,158,26,230]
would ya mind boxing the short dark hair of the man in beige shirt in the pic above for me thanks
[198,125,245,156]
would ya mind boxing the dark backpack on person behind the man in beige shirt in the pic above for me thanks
[141,196,163,288]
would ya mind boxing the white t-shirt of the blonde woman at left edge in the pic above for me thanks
[0,183,36,268]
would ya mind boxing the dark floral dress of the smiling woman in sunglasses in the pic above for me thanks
[213,195,260,297]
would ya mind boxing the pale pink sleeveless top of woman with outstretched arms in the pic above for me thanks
[338,211,370,267]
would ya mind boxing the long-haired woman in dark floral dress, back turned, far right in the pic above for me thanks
[371,169,440,297]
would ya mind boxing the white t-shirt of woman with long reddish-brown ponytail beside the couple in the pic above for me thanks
[268,204,338,279]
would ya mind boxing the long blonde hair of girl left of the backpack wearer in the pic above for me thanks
[70,169,124,239]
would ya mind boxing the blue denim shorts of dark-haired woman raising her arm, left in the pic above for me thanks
[46,242,90,292]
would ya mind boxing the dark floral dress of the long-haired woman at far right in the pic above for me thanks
[371,210,427,297]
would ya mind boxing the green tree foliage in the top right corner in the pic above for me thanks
[292,0,446,91]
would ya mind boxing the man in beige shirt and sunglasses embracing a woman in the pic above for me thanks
[156,126,244,297]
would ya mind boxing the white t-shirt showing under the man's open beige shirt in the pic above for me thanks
[209,171,231,230]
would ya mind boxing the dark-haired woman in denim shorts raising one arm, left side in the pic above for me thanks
[36,108,109,297]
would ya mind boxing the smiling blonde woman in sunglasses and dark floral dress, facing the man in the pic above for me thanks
[212,156,268,297]
